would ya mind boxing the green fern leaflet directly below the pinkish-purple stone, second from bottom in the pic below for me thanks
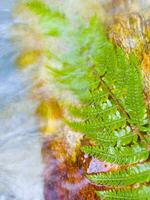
[88,163,150,186]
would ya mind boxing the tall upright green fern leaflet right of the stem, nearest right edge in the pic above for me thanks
[125,55,145,126]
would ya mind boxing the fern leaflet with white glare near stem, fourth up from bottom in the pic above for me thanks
[67,115,137,146]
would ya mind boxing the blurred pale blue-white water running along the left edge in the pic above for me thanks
[0,0,43,200]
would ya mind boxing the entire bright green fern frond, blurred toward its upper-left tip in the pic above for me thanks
[22,0,150,200]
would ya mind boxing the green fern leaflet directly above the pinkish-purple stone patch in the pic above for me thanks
[82,144,149,165]
